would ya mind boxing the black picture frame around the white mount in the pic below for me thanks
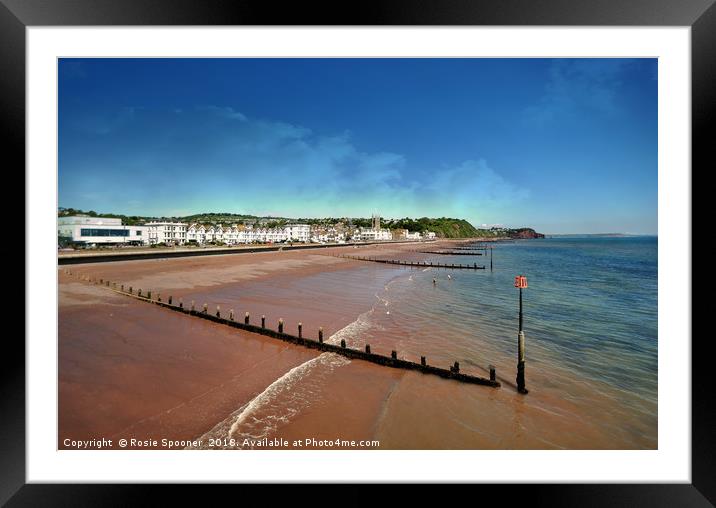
[0,0,716,507]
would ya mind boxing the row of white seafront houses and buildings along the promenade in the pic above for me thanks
[57,215,435,245]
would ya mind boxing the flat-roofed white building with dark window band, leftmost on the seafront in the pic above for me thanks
[57,215,148,245]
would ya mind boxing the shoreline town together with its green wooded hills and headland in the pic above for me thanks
[57,209,542,250]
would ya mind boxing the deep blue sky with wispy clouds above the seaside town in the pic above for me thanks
[58,59,657,234]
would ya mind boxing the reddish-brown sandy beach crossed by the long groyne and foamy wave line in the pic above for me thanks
[58,243,653,449]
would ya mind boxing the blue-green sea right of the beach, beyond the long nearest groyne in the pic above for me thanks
[362,237,658,443]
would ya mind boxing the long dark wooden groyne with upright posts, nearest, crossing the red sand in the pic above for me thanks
[65,271,501,388]
